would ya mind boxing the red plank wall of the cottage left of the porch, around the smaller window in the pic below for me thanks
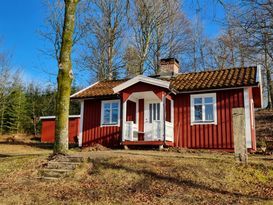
[82,100,122,147]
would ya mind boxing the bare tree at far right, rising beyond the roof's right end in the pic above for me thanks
[226,0,273,109]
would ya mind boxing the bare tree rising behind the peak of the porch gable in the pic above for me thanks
[129,0,170,75]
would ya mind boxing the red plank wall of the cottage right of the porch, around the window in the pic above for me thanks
[174,89,244,149]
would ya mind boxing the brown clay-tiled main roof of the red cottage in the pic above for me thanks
[71,66,258,99]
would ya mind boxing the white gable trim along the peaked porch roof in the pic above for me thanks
[113,75,170,93]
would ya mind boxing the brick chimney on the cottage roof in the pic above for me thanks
[159,58,179,76]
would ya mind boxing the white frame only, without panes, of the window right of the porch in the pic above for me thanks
[191,93,217,125]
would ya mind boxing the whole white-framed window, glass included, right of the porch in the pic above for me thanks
[191,93,217,124]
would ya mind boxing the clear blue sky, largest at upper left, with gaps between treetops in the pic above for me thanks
[0,0,224,85]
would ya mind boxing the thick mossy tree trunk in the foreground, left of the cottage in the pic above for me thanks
[54,0,78,154]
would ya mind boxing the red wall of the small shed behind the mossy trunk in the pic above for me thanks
[41,117,80,144]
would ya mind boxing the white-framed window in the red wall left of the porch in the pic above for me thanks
[101,100,119,125]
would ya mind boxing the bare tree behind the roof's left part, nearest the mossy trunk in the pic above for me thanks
[81,0,127,80]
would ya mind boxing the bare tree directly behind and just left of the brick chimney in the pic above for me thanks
[148,1,191,74]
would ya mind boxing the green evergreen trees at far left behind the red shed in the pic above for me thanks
[0,69,80,136]
